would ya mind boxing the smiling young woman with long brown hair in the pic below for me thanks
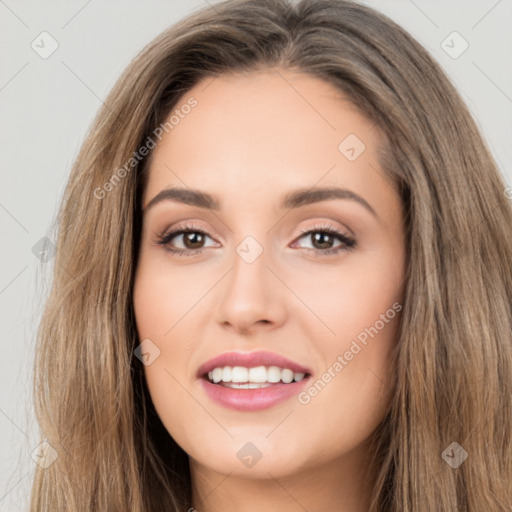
[31,0,512,512]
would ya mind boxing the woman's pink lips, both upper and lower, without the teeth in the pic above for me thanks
[197,351,311,411]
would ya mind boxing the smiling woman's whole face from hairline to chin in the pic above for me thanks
[134,70,405,484]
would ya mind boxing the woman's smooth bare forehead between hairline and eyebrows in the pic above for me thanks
[145,69,392,209]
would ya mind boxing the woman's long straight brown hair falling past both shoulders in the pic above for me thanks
[31,0,512,512]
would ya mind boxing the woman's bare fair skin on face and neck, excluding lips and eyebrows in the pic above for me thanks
[134,69,405,512]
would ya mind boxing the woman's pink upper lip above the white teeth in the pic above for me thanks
[197,350,311,378]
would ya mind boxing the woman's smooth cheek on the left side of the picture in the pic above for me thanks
[133,253,212,428]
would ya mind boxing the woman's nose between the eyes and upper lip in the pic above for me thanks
[216,244,290,335]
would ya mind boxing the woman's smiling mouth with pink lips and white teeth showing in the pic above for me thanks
[197,352,312,411]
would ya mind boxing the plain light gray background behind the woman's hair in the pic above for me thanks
[0,0,512,512]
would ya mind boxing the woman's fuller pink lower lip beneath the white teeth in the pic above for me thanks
[201,377,310,411]
